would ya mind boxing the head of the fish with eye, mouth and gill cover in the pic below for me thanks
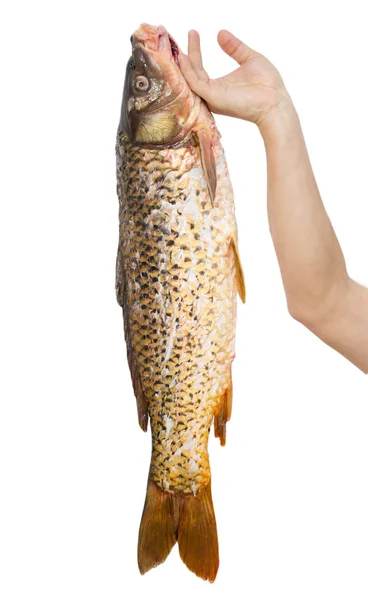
[119,24,200,147]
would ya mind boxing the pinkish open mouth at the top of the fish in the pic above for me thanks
[130,23,179,65]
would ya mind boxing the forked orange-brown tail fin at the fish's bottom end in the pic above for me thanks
[138,482,219,583]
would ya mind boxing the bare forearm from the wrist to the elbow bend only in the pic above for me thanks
[260,101,348,320]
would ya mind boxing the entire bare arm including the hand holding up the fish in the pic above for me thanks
[180,31,368,373]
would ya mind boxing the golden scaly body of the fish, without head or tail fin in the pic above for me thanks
[116,130,240,495]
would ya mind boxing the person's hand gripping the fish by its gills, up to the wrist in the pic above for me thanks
[179,30,291,126]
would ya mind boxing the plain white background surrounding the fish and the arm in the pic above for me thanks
[0,0,368,600]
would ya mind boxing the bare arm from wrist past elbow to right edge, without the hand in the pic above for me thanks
[260,97,368,373]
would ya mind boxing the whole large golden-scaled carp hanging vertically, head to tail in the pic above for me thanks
[116,24,245,581]
